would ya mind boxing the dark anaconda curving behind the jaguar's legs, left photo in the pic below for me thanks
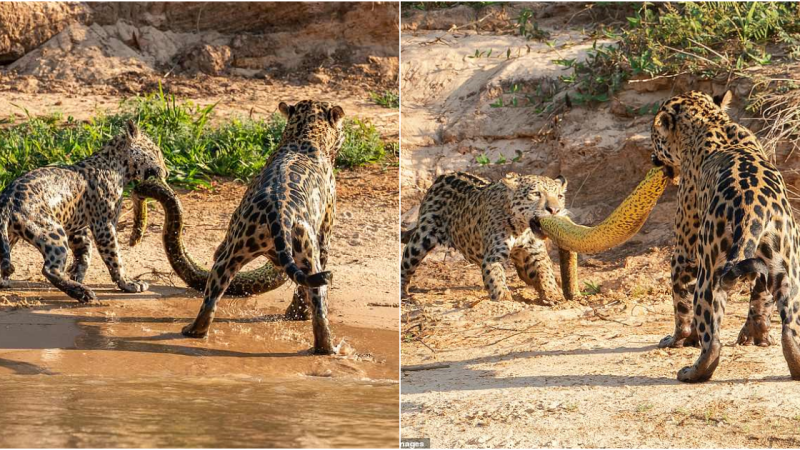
[130,178,287,296]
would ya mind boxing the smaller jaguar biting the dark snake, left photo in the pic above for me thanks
[0,122,168,302]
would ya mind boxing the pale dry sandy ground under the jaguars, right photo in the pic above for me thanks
[401,244,800,448]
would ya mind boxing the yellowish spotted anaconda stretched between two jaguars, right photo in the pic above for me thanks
[538,167,669,255]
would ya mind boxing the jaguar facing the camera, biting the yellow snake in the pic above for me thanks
[400,172,567,303]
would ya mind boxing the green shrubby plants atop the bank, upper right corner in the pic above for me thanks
[554,2,800,110]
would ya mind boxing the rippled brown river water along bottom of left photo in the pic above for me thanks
[0,374,399,448]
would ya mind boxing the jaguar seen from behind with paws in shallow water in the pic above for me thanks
[183,100,345,354]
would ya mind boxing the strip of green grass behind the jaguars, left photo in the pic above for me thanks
[0,90,386,189]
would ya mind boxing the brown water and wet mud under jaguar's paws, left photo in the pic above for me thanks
[0,291,399,448]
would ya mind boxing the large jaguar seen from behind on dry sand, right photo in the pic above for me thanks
[652,92,800,382]
